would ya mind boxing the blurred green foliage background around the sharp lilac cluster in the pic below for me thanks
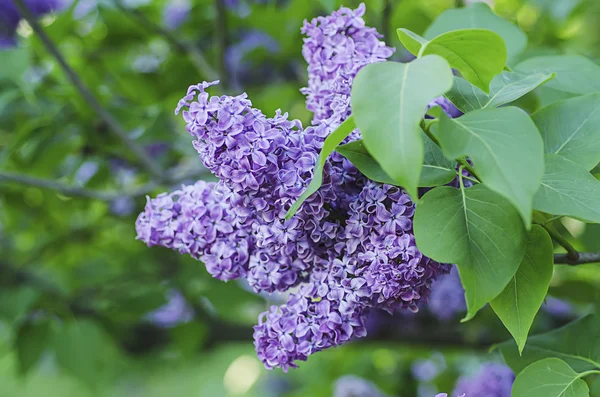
[0,0,600,397]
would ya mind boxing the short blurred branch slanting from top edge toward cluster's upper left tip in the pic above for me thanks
[115,0,219,81]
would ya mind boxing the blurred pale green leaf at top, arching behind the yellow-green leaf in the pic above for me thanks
[424,2,527,59]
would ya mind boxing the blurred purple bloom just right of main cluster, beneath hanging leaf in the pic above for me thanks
[427,266,467,321]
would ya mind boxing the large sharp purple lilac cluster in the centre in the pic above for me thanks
[136,5,449,370]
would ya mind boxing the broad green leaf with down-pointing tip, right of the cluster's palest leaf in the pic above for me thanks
[437,107,544,226]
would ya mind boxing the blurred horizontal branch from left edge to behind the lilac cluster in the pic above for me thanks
[0,171,208,201]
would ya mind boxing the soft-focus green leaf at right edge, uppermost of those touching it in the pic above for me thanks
[515,55,600,95]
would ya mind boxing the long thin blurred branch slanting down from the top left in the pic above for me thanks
[15,0,164,180]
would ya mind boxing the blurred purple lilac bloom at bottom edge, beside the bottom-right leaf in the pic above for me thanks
[454,363,515,397]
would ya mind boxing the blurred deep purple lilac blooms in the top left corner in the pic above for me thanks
[0,0,70,49]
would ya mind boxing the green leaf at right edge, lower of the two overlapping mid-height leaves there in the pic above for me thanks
[533,154,600,223]
